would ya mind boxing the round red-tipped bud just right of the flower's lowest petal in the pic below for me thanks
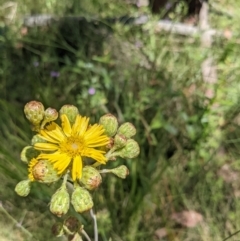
[80,166,102,190]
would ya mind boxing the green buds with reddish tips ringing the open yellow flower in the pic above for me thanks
[15,101,140,240]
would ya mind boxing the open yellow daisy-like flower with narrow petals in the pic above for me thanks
[34,114,109,181]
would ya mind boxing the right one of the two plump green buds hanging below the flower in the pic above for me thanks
[71,186,93,213]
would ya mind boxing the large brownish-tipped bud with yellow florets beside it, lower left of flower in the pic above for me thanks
[32,160,61,183]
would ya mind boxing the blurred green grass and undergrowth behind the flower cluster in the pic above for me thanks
[0,0,240,241]
